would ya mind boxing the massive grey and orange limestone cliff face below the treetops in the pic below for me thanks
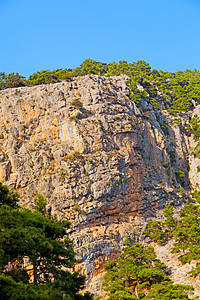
[0,75,199,291]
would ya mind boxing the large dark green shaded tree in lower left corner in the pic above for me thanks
[0,184,92,299]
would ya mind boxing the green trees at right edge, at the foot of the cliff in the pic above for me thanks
[145,198,200,276]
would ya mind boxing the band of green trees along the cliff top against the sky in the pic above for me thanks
[0,59,200,114]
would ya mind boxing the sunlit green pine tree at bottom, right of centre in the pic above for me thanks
[104,244,192,300]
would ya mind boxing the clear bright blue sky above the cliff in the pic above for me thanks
[0,0,200,77]
